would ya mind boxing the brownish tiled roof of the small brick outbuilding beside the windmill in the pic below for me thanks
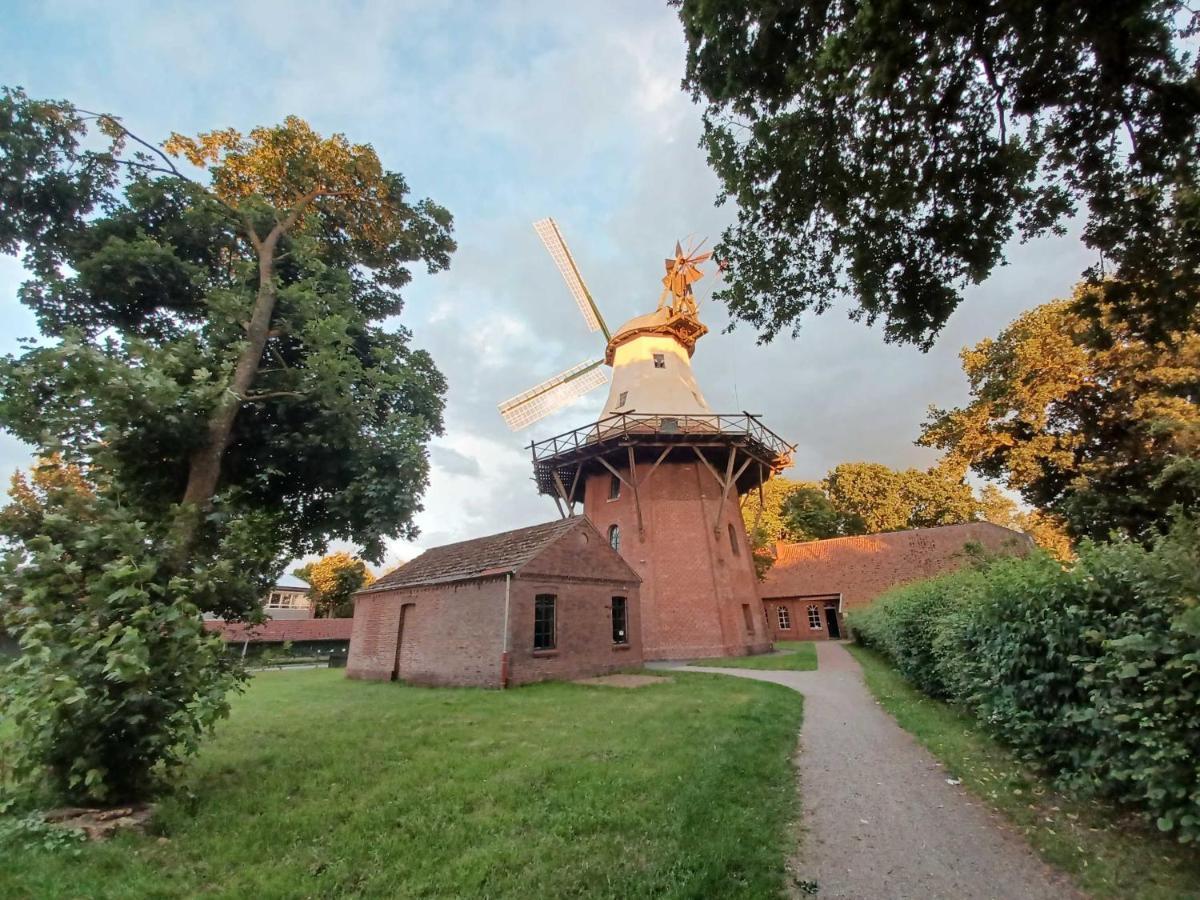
[359,516,587,594]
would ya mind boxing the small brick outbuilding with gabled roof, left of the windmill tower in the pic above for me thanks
[347,516,642,688]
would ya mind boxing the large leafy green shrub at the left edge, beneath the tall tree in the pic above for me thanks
[0,497,241,802]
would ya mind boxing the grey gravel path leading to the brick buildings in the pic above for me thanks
[686,642,1081,900]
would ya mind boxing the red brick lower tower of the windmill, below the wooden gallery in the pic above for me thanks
[584,458,770,659]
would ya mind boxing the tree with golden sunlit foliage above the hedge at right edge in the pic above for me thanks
[919,284,1200,540]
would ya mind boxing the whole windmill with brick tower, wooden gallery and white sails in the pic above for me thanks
[499,218,794,659]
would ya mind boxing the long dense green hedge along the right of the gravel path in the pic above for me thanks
[851,521,1200,841]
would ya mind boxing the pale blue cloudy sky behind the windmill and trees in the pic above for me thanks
[0,0,1091,571]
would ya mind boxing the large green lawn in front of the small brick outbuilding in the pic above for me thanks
[0,670,802,900]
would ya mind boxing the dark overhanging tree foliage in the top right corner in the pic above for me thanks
[673,0,1200,348]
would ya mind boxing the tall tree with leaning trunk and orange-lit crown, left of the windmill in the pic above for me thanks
[0,90,454,796]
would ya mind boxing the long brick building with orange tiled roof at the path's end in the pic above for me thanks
[758,522,1033,641]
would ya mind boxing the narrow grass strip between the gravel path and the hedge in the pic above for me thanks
[850,644,1200,900]
